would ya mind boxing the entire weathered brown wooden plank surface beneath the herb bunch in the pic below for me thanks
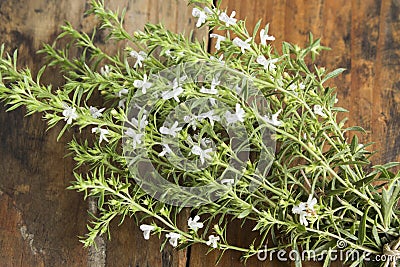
[0,0,400,267]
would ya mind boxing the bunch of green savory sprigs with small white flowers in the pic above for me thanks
[0,0,400,266]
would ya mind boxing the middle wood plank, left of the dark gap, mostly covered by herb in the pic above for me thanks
[101,0,207,267]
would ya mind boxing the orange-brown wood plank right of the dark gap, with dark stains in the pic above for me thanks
[190,0,400,267]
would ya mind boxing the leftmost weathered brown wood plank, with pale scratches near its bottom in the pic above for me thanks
[0,0,93,266]
